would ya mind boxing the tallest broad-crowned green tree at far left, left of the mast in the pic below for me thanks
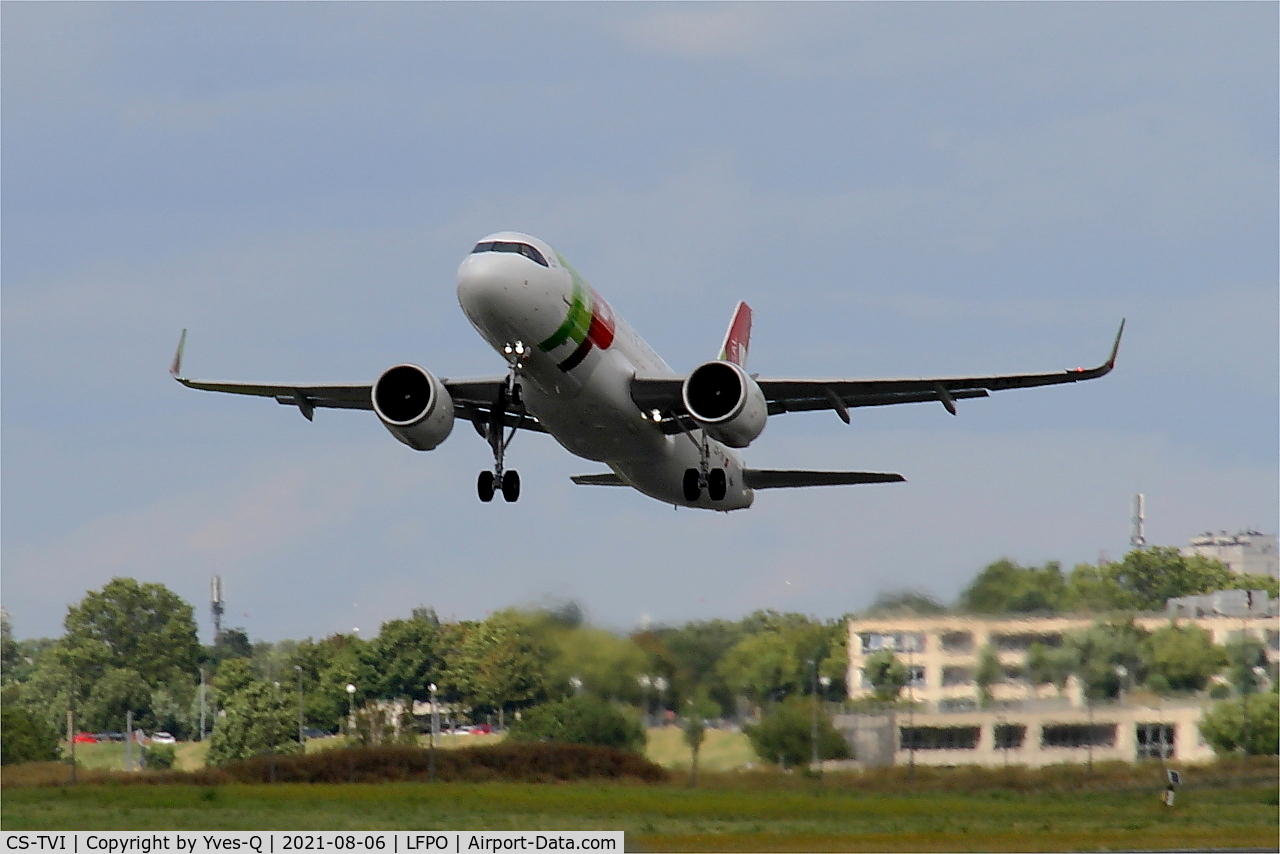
[60,577,200,694]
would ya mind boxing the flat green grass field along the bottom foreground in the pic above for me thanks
[0,772,1277,851]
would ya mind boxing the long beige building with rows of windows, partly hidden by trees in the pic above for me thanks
[836,604,1280,767]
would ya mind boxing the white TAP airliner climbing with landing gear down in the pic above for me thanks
[169,232,1124,511]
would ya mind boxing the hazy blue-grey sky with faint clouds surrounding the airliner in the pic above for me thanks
[0,3,1280,640]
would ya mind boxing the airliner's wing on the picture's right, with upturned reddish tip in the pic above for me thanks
[631,320,1124,433]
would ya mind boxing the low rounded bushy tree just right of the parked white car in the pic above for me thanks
[207,681,298,766]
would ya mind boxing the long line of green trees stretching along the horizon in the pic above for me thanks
[0,548,1277,753]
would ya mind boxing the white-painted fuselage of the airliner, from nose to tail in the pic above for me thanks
[458,232,754,511]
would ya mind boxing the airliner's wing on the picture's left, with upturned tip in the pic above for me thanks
[169,329,547,433]
